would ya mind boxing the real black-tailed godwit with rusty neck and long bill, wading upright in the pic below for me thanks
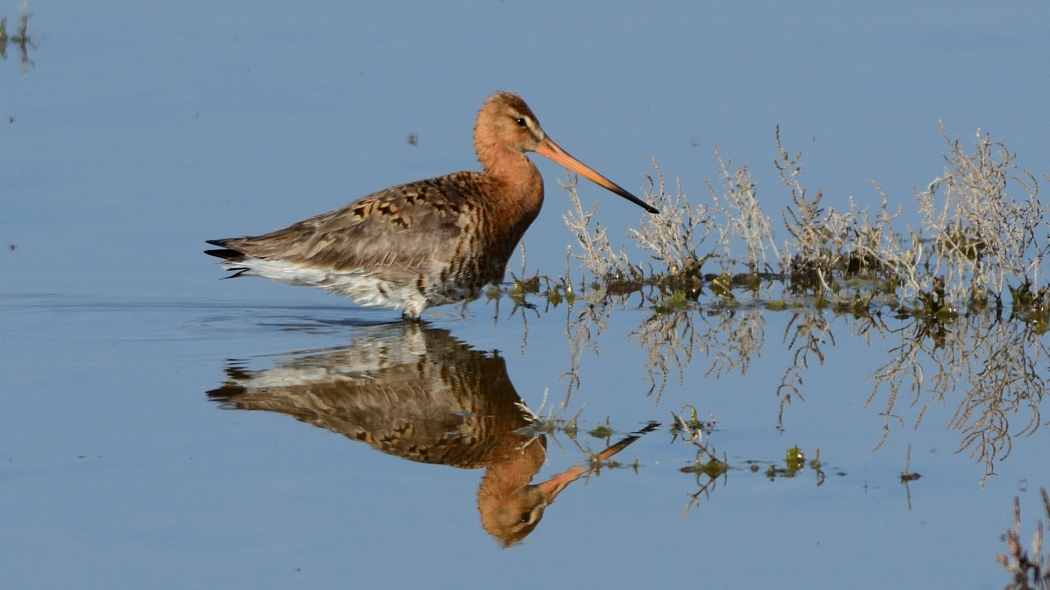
[206,92,657,319]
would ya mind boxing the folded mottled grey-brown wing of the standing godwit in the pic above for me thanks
[215,172,488,272]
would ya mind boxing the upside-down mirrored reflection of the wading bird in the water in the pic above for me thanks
[208,323,636,547]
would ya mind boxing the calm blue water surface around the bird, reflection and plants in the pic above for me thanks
[0,1,1050,588]
